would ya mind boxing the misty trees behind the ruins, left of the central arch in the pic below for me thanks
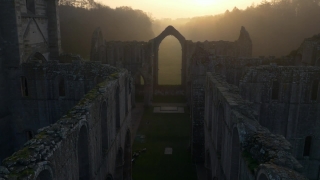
[59,1,154,59]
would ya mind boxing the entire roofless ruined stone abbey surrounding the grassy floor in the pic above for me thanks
[0,0,320,180]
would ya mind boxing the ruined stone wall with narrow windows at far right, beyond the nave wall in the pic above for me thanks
[240,65,320,179]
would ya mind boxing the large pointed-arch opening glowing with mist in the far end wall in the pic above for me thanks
[158,36,182,85]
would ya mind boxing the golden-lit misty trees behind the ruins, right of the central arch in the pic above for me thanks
[154,0,320,56]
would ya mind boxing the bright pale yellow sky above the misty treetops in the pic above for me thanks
[100,0,262,19]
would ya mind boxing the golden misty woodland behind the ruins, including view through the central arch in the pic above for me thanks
[60,0,320,84]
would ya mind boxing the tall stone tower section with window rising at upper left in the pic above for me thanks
[0,0,61,67]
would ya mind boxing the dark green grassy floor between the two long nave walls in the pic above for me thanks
[133,108,197,180]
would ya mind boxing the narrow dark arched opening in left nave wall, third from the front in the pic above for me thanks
[100,102,109,157]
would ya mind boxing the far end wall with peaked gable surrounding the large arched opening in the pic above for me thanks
[90,26,252,105]
